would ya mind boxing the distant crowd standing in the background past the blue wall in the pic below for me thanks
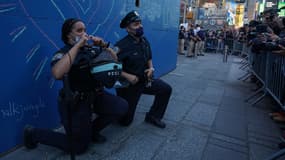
[178,24,248,57]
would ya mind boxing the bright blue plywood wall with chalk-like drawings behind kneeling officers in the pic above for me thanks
[0,0,180,153]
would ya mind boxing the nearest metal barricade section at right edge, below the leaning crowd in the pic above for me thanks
[248,49,285,110]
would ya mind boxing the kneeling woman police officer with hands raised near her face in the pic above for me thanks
[24,18,128,154]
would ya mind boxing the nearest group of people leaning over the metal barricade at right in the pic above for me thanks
[245,9,285,149]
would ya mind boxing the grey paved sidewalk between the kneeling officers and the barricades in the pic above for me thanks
[1,54,285,160]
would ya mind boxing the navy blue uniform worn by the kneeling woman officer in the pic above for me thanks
[25,45,128,154]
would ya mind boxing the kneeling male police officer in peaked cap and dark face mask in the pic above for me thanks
[115,11,172,128]
